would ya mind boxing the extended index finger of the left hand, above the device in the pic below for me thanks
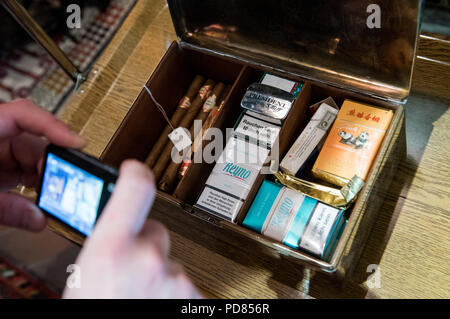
[0,100,85,148]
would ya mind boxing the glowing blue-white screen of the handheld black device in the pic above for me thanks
[39,153,105,236]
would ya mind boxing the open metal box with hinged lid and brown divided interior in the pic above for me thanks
[54,0,420,276]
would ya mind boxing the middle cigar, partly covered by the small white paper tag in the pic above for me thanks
[153,79,215,181]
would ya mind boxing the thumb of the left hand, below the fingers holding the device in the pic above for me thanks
[0,193,47,232]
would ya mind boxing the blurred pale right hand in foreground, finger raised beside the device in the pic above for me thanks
[64,160,201,299]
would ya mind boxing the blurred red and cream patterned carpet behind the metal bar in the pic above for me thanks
[0,0,136,112]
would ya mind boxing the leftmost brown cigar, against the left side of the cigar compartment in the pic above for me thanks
[145,75,205,167]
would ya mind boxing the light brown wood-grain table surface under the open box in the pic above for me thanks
[59,0,450,298]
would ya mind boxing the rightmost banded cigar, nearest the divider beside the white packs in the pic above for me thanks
[158,83,226,192]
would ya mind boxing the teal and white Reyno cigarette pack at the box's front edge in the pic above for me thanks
[243,181,345,260]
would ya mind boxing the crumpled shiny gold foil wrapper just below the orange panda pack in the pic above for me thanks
[274,172,364,209]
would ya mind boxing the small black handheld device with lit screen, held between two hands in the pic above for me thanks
[37,145,119,237]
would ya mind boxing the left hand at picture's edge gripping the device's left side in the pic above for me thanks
[0,100,85,231]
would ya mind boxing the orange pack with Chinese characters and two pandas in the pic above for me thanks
[313,100,394,186]
